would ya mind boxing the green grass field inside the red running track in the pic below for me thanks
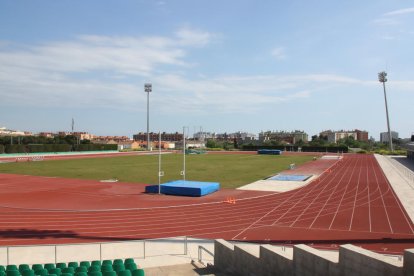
[0,154,312,188]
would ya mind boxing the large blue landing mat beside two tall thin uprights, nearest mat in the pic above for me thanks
[145,180,220,197]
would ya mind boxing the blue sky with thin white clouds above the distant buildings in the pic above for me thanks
[0,0,414,139]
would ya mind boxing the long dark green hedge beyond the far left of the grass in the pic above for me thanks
[0,144,118,153]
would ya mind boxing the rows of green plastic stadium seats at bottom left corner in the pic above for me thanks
[0,258,145,276]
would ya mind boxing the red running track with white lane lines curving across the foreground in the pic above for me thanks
[0,155,414,253]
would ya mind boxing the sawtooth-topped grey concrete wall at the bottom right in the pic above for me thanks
[214,240,414,276]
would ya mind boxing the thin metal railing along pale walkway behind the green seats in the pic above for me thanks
[0,236,188,265]
